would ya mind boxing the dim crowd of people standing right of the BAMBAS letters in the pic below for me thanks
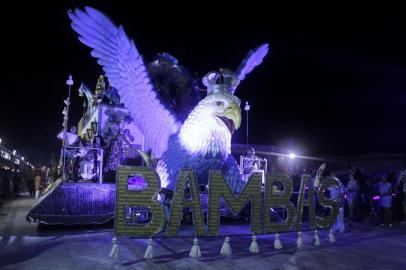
[308,168,406,232]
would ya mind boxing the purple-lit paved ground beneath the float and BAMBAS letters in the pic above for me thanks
[0,197,406,270]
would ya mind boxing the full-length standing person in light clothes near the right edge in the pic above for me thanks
[379,175,393,227]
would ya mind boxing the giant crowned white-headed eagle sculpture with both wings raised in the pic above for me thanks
[68,7,268,193]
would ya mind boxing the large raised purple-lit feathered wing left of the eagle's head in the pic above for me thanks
[68,7,181,157]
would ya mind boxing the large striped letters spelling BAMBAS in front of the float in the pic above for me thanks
[115,166,338,237]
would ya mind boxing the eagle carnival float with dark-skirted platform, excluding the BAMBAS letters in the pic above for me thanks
[27,7,268,224]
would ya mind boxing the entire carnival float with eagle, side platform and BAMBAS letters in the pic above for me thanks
[27,7,338,249]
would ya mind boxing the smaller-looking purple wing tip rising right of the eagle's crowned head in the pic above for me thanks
[231,43,269,94]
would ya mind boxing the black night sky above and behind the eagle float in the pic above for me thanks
[0,1,406,165]
